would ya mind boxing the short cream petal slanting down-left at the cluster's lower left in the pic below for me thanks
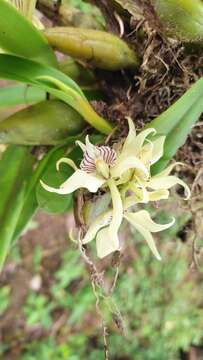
[82,211,112,244]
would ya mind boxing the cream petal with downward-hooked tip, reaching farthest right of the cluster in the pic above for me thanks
[147,175,191,200]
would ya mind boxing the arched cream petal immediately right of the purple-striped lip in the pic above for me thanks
[111,155,149,178]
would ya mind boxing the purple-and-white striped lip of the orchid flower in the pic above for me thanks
[80,146,116,173]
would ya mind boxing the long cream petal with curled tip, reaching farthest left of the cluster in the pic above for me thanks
[40,170,105,194]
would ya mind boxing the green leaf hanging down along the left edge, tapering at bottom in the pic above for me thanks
[0,145,33,268]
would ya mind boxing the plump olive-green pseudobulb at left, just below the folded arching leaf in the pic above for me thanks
[0,100,85,145]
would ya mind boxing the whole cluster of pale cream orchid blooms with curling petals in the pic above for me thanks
[41,119,190,260]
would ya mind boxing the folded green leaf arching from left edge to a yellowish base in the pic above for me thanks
[0,54,112,134]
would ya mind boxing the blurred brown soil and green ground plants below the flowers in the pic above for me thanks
[0,200,203,360]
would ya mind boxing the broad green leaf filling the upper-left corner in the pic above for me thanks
[0,0,57,66]
